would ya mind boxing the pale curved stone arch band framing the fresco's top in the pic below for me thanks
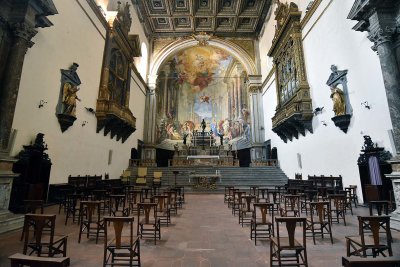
[149,37,257,83]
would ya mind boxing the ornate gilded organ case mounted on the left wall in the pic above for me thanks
[96,4,140,142]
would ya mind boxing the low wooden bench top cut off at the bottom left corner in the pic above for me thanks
[8,253,69,267]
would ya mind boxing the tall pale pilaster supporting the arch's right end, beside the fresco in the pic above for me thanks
[247,75,266,163]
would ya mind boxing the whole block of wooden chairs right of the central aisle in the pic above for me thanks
[224,186,393,266]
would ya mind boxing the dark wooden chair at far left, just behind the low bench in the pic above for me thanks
[23,213,67,257]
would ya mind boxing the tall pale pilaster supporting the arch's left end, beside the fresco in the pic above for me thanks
[142,75,157,165]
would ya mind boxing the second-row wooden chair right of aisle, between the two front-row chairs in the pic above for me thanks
[306,202,333,245]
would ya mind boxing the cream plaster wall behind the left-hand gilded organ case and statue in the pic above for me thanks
[12,0,145,183]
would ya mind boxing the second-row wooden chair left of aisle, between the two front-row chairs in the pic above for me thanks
[78,201,106,244]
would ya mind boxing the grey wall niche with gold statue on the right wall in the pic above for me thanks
[326,65,353,133]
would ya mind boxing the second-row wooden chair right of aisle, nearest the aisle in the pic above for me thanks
[250,203,274,245]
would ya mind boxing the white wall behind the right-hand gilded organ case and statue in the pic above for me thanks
[263,1,392,201]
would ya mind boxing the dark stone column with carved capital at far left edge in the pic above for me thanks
[0,23,37,150]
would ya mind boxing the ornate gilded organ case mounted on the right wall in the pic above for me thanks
[268,3,313,142]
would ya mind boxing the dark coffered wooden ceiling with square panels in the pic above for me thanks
[132,0,271,37]
